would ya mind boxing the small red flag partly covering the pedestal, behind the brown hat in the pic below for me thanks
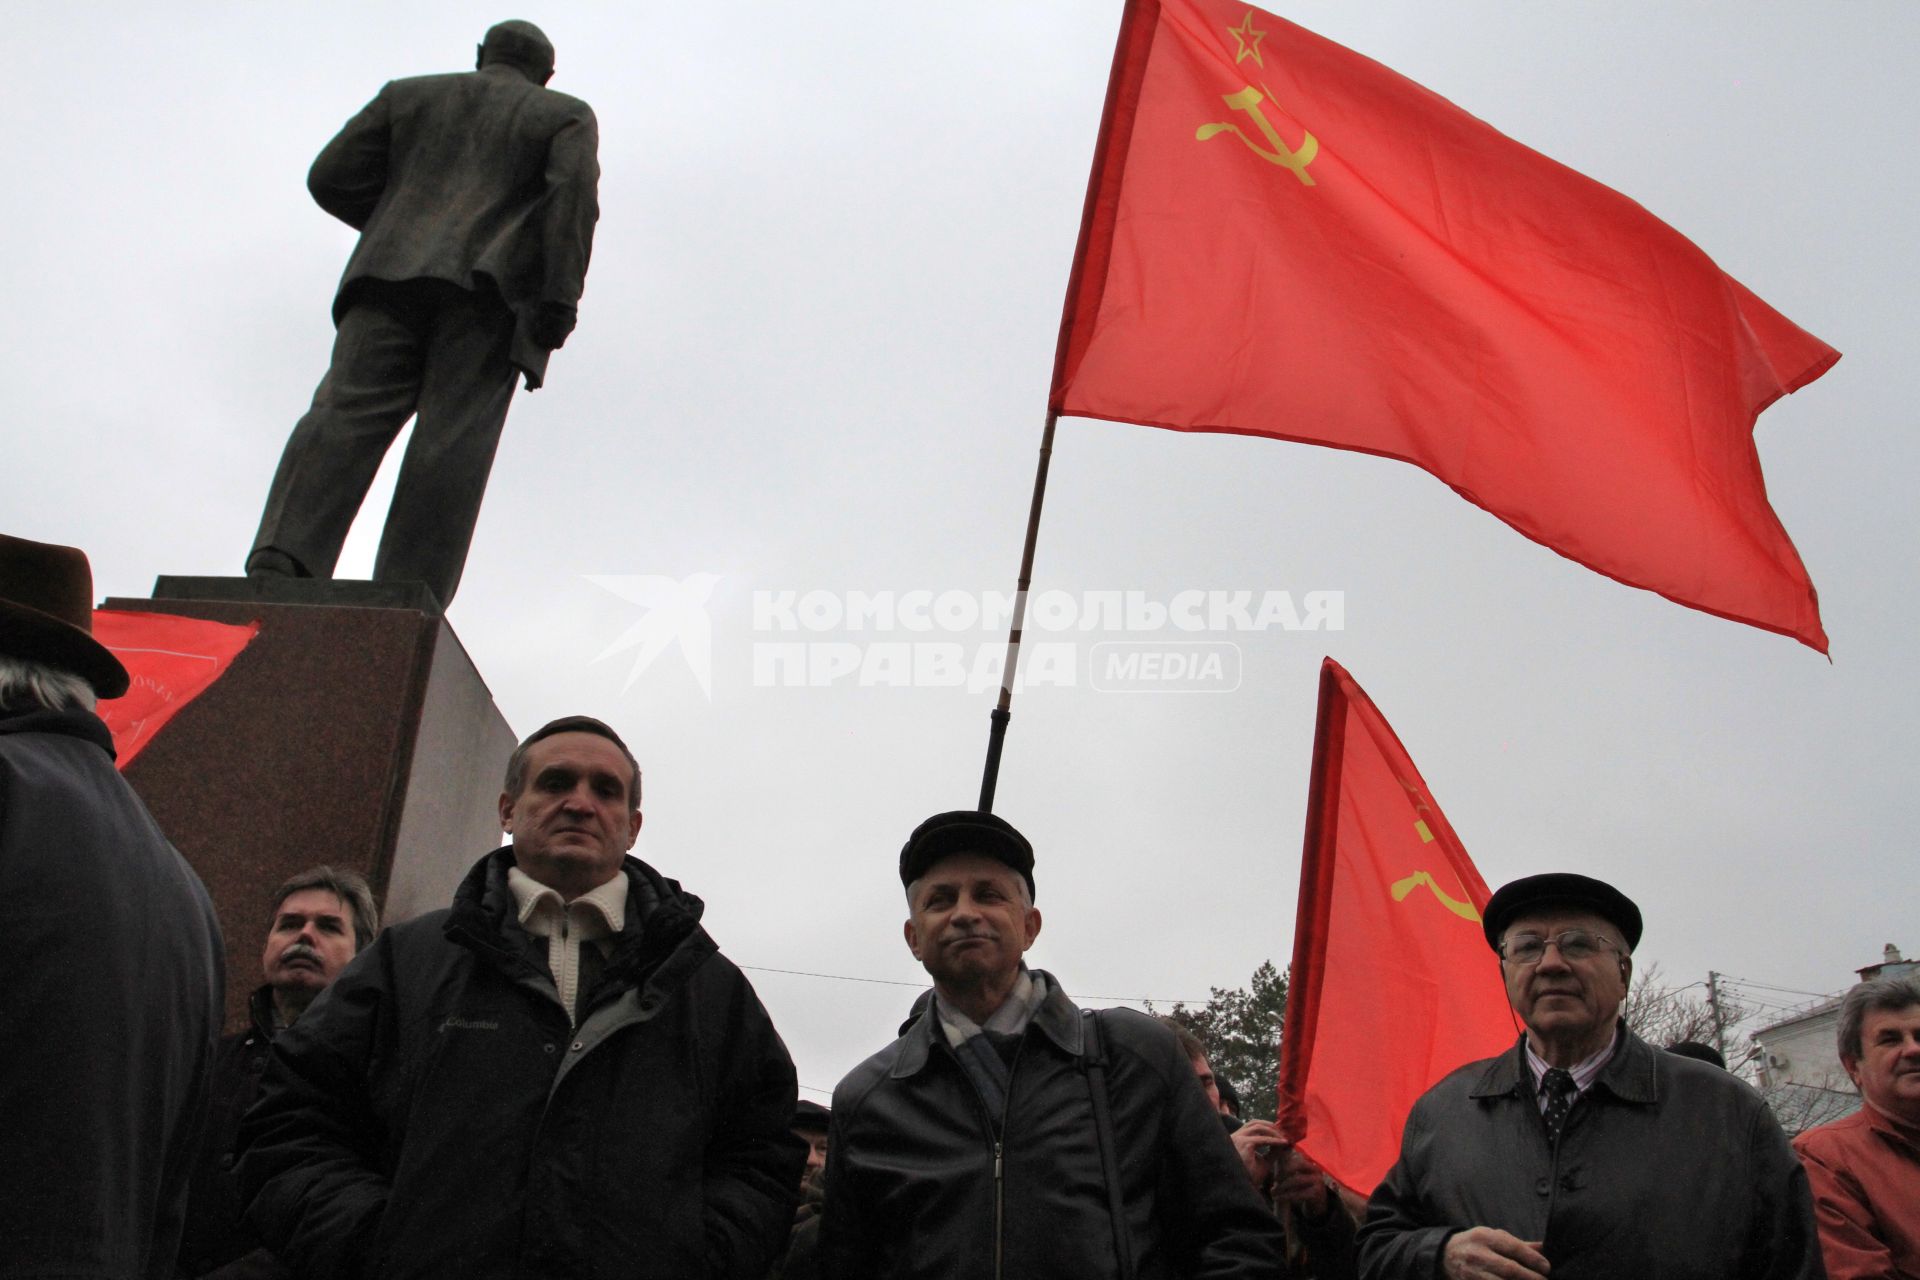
[94,608,259,770]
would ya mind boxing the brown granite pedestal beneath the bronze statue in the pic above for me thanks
[104,578,516,1029]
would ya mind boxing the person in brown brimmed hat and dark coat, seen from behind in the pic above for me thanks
[0,535,225,1280]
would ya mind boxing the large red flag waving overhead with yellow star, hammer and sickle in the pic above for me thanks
[1050,0,1839,652]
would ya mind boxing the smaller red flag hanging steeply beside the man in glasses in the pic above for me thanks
[1279,658,1519,1196]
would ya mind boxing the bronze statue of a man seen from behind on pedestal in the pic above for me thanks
[246,21,599,604]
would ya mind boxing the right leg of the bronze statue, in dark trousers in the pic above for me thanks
[372,290,515,606]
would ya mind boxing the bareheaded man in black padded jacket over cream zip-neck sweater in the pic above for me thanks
[240,716,806,1280]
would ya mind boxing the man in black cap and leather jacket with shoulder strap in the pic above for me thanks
[822,810,1281,1280]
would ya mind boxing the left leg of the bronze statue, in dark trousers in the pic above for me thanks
[248,301,424,578]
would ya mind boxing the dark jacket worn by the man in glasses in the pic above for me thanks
[1359,1031,1826,1280]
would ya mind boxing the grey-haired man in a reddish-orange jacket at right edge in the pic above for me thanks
[1793,971,1920,1280]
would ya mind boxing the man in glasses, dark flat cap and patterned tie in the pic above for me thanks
[1359,873,1824,1280]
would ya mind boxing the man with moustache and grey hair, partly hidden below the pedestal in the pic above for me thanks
[177,865,380,1280]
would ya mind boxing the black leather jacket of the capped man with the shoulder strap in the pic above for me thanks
[822,975,1281,1280]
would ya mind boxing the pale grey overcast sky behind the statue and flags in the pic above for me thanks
[11,0,1920,1090]
